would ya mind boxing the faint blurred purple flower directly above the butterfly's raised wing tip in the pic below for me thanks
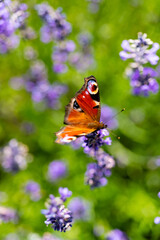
[69,33,95,72]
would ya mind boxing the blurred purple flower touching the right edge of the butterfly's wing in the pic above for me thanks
[100,105,118,129]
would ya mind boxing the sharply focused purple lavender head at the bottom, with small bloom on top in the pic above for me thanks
[42,188,72,232]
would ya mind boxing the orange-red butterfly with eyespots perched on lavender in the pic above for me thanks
[56,76,107,144]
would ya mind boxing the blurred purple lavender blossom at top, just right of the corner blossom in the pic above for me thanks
[35,3,72,43]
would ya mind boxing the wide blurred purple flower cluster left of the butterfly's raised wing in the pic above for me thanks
[10,60,68,109]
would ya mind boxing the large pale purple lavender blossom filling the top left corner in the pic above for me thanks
[0,0,28,54]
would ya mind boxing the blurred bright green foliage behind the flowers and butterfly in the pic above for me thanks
[0,0,160,240]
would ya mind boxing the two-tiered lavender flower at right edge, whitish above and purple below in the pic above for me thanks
[120,33,159,96]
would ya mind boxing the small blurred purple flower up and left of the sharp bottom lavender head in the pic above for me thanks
[25,181,41,201]
